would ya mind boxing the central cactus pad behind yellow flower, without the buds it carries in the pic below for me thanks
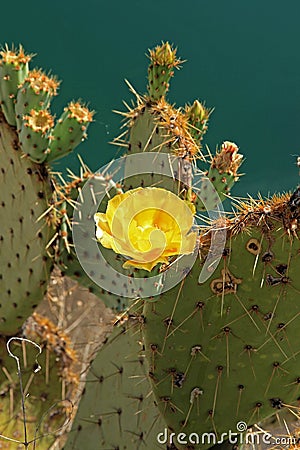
[114,95,204,205]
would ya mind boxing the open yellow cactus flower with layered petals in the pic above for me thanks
[95,187,197,272]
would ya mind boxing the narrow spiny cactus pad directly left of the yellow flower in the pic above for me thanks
[54,171,128,311]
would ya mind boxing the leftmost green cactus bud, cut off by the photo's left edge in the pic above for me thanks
[0,45,31,126]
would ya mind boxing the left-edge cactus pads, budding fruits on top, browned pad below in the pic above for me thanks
[0,43,117,449]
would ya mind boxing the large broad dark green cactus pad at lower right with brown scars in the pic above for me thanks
[142,194,300,449]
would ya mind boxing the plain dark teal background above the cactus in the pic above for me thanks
[0,0,300,196]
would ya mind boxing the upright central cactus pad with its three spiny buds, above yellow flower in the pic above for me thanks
[114,43,242,210]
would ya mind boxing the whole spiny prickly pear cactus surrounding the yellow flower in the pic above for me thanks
[0,39,300,450]
